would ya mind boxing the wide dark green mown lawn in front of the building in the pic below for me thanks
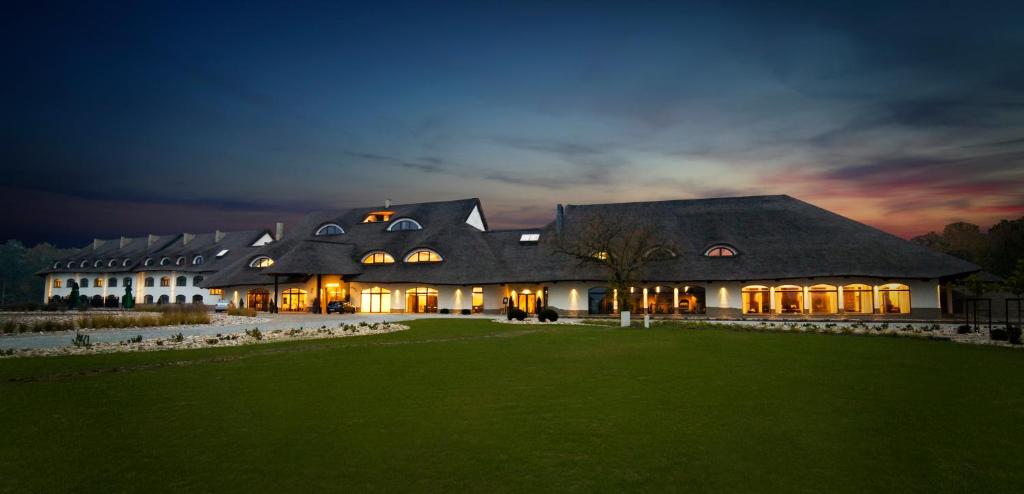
[0,320,1024,492]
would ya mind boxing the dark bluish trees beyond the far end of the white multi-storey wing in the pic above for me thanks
[0,240,77,303]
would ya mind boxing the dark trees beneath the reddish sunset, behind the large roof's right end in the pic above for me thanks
[911,217,1024,278]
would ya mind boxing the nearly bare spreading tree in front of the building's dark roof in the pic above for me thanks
[552,211,676,311]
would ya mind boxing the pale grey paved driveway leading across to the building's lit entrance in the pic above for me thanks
[0,313,497,348]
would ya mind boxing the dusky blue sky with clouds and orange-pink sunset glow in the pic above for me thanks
[0,0,1024,245]
